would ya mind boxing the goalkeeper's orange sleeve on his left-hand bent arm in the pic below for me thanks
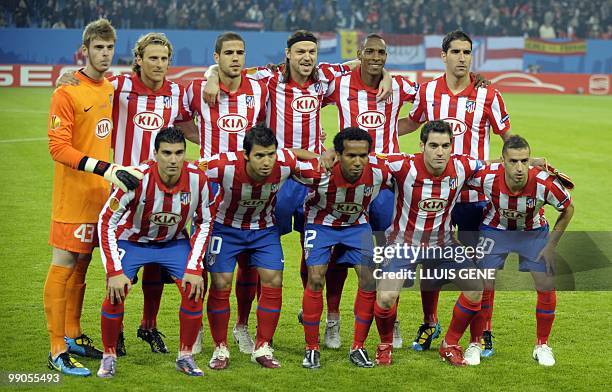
[47,88,85,170]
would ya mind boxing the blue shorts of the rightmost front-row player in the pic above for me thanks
[478,226,548,272]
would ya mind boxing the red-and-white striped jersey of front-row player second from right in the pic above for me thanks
[386,154,482,246]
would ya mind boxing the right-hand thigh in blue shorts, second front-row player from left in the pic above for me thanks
[247,227,285,274]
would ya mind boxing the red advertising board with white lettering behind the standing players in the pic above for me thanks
[0,64,612,95]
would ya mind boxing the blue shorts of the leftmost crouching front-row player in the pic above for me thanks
[117,239,191,280]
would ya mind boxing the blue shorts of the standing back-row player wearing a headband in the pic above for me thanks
[274,178,308,235]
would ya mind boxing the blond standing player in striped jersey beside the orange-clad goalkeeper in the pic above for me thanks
[58,33,191,356]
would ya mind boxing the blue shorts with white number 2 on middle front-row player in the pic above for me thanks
[304,223,374,266]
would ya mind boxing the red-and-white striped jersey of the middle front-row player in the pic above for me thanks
[294,154,393,227]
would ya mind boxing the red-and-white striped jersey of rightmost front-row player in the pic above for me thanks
[467,163,572,230]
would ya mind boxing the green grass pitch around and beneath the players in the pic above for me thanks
[0,88,612,391]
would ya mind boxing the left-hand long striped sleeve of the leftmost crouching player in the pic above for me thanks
[98,187,140,277]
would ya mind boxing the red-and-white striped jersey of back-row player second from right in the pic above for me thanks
[325,67,417,154]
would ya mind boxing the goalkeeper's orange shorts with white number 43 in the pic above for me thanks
[49,221,98,253]
